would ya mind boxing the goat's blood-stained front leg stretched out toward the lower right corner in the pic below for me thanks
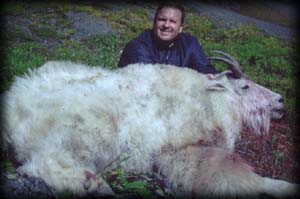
[157,146,297,197]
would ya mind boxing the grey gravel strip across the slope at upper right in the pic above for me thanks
[187,1,296,41]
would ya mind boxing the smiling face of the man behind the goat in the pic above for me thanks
[153,7,183,41]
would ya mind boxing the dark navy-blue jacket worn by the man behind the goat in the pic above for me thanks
[119,30,216,74]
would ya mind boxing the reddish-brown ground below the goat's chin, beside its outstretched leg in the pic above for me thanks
[236,118,300,183]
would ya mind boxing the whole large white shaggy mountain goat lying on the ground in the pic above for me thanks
[3,51,296,197]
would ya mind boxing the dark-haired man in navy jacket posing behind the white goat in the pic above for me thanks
[119,3,216,79]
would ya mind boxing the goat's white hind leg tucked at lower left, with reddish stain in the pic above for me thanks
[18,153,114,196]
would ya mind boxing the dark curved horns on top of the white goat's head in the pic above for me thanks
[208,50,244,78]
